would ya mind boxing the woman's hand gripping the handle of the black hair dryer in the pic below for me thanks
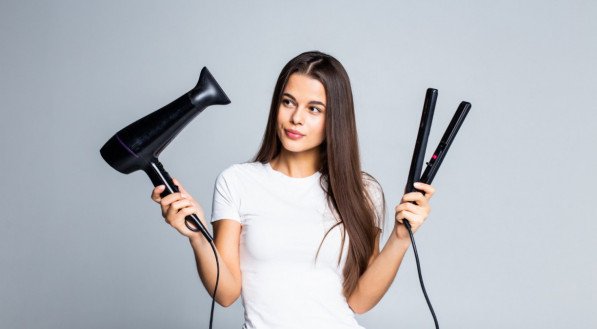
[151,178,207,239]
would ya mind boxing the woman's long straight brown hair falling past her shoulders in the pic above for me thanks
[253,51,385,297]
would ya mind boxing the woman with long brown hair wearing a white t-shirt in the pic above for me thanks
[152,52,434,329]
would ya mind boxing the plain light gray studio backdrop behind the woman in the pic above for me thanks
[0,0,597,329]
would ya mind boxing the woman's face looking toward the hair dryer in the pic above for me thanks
[277,73,326,156]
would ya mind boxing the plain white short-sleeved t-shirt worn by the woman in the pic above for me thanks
[211,162,384,329]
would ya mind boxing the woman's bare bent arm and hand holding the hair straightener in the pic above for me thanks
[347,183,435,314]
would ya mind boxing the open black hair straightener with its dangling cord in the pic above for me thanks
[403,88,471,329]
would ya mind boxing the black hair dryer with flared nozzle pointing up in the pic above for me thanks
[100,67,230,242]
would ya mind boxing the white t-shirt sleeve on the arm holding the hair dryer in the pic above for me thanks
[211,168,241,223]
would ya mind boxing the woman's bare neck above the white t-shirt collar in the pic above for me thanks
[270,149,320,178]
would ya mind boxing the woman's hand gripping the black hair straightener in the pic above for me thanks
[394,182,435,241]
